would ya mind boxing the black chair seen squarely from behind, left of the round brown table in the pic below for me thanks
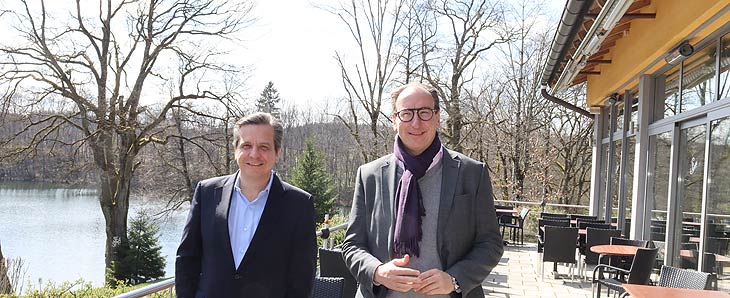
[540,226,578,279]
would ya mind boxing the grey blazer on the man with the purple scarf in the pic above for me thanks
[342,150,504,298]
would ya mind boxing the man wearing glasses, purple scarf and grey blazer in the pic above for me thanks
[343,83,503,297]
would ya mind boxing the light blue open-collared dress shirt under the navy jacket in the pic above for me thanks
[228,171,274,269]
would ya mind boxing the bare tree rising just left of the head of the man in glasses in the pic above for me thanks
[329,0,405,161]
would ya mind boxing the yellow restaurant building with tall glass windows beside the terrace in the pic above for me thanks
[542,0,730,291]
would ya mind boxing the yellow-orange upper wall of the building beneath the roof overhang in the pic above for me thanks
[587,0,730,106]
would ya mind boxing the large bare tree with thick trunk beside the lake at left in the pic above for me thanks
[0,0,251,280]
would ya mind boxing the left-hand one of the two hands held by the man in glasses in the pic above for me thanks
[373,255,421,292]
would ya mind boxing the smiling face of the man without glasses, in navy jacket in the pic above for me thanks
[235,125,281,179]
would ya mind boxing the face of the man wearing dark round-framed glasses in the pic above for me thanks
[392,87,440,156]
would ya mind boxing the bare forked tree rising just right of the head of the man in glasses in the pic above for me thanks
[420,0,512,151]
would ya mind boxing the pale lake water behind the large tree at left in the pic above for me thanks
[0,183,189,290]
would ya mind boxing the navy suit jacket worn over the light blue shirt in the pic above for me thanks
[175,174,317,298]
